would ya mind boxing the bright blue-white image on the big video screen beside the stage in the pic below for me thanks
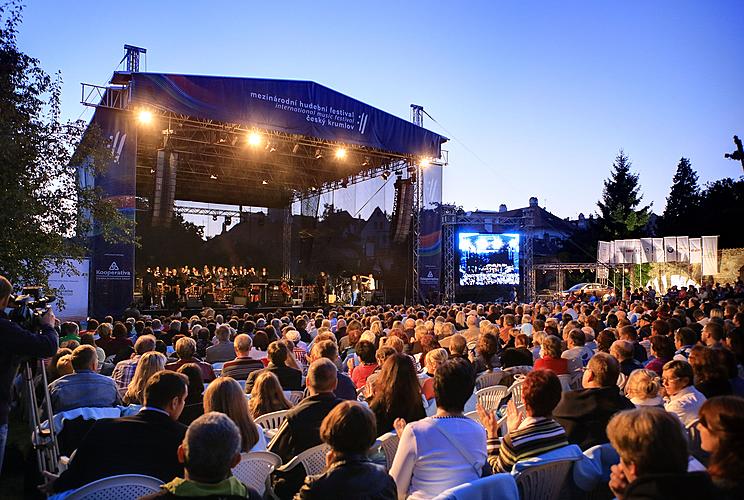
[457,233,519,287]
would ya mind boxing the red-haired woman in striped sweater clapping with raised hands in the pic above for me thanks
[477,370,568,473]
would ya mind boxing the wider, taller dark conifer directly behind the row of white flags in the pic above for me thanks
[597,149,651,239]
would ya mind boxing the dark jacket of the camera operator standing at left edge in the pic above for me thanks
[0,311,57,425]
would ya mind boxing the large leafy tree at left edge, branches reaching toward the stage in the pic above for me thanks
[0,2,134,292]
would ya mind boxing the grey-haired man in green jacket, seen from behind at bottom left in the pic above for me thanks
[141,412,261,500]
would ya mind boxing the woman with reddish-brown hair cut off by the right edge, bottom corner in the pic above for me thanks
[698,396,744,499]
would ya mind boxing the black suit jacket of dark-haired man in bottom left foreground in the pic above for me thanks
[54,410,186,492]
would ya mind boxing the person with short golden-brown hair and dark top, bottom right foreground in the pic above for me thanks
[607,407,718,500]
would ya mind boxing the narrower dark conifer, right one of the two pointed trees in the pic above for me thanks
[658,157,700,235]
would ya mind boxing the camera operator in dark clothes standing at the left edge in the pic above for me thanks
[0,276,57,470]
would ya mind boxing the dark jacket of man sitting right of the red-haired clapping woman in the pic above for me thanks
[553,386,635,450]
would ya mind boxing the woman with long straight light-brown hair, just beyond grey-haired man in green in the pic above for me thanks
[204,377,266,452]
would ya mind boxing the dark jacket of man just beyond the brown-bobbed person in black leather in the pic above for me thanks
[269,393,343,464]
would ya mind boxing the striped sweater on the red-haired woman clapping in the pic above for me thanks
[487,418,568,473]
